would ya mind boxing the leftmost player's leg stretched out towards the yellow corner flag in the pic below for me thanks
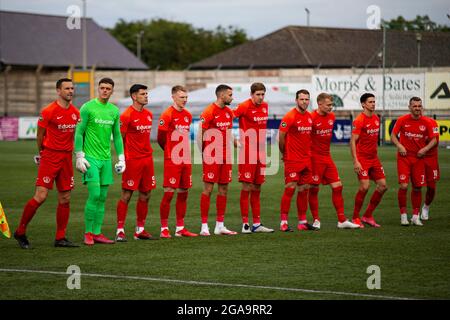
[14,186,49,249]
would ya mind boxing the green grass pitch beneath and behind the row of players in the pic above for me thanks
[0,141,450,299]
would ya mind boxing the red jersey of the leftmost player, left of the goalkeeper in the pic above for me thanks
[38,101,80,151]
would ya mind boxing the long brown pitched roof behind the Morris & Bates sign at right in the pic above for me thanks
[191,26,450,70]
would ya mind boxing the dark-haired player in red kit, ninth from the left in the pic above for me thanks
[350,93,387,228]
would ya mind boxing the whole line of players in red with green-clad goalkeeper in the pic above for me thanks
[14,78,439,249]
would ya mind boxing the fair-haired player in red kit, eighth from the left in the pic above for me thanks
[308,93,359,229]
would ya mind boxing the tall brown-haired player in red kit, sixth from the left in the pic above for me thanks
[233,82,274,233]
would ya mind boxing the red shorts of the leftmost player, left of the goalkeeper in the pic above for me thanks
[36,149,74,192]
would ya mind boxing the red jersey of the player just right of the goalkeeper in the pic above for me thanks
[120,106,153,159]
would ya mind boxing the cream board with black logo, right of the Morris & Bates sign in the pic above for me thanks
[425,72,450,110]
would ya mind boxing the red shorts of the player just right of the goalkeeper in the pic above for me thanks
[122,156,156,192]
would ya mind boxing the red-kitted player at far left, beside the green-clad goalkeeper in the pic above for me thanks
[14,78,80,249]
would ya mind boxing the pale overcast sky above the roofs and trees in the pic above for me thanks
[0,0,450,38]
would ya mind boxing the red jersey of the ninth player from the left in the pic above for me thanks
[352,113,380,159]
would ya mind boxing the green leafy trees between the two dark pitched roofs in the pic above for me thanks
[108,19,248,70]
